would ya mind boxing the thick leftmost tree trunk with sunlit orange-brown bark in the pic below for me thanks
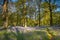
[2,0,8,28]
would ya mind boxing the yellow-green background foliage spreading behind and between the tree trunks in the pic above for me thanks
[0,0,60,26]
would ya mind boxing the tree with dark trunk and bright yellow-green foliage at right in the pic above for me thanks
[38,0,56,25]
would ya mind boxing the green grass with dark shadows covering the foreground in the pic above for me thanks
[0,29,60,40]
